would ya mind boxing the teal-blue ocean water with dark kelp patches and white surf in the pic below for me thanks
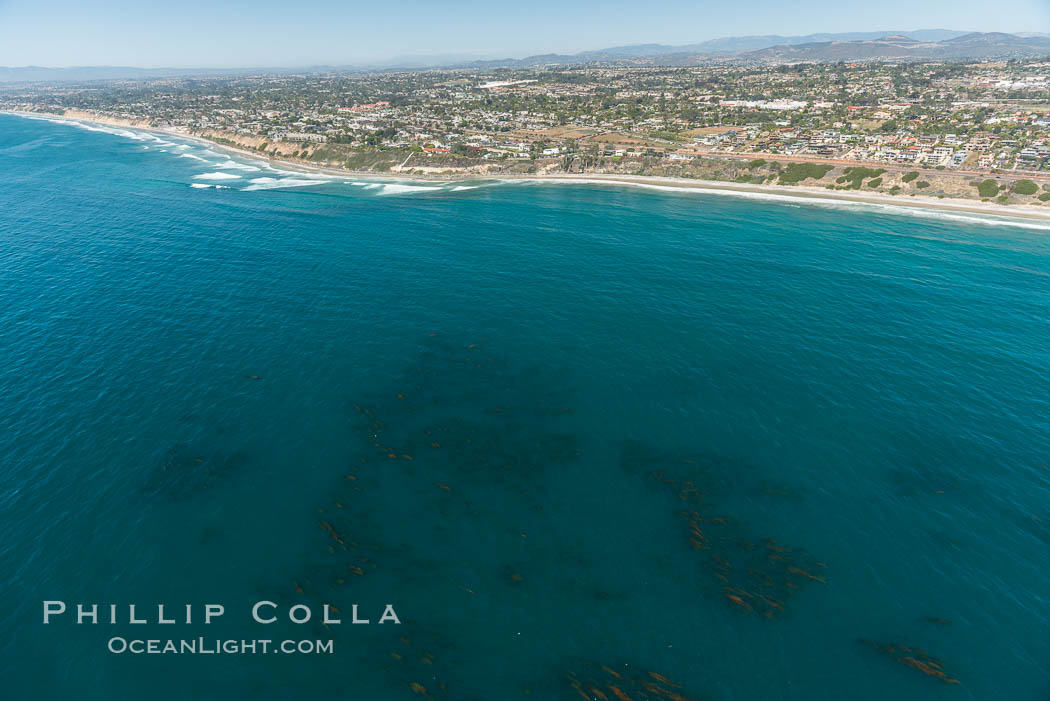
[0,115,1050,701]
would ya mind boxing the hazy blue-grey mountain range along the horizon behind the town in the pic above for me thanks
[0,29,1050,83]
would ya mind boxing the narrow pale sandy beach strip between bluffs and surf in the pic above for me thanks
[8,111,1050,225]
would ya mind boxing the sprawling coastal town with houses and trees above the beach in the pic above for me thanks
[6,60,1050,207]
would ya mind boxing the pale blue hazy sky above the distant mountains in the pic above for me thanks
[0,0,1050,67]
